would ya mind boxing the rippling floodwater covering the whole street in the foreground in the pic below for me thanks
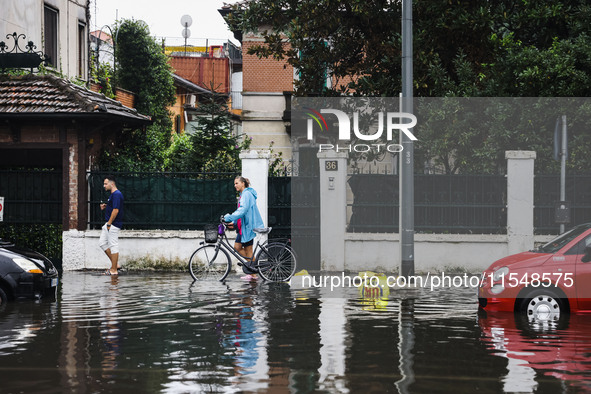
[0,272,591,393]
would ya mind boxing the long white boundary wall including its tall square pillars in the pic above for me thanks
[63,151,552,273]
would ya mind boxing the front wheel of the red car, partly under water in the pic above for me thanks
[519,288,568,320]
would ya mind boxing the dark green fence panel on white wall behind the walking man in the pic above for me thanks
[88,172,238,230]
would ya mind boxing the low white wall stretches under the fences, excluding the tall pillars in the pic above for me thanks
[64,230,553,273]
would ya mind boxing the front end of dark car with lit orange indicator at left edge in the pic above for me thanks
[0,239,58,306]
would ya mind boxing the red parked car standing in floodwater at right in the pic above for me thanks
[478,223,591,320]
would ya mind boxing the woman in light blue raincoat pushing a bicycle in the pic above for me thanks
[224,176,265,279]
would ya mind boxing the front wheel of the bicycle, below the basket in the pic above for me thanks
[189,245,232,282]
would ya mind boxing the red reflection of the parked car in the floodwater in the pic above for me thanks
[478,313,591,392]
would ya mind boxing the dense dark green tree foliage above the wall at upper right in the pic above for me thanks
[226,0,591,172]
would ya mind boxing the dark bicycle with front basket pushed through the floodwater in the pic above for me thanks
[189,216,296,282]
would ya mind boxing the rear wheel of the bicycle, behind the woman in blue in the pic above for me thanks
[256,243,296,282]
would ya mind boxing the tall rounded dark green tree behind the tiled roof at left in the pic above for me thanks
[99,19,176,171]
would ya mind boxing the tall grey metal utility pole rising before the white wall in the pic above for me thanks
[399,0,415,276]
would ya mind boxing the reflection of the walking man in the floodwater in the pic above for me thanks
[100,276,123,378]
